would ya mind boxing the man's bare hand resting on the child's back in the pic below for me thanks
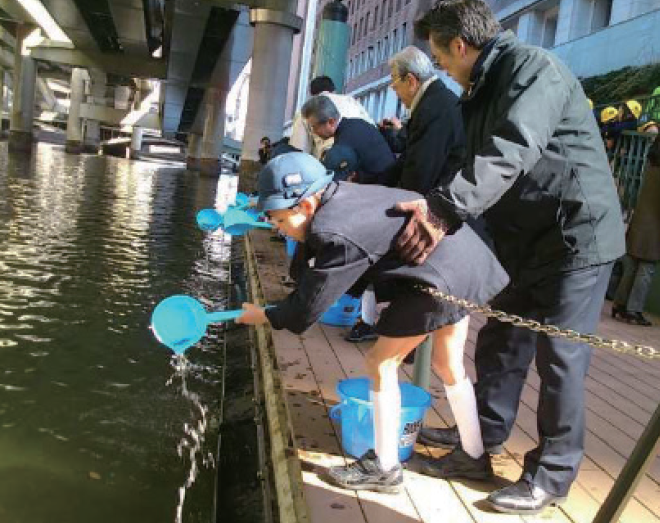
[394,198,447,265]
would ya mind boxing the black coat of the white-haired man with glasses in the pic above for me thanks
[385,79,465,194]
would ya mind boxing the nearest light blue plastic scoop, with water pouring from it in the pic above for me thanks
[151,294,244,354]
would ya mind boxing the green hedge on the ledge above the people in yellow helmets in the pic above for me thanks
[581,63,660,105]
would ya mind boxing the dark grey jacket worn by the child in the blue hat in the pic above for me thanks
[266,182,508,333]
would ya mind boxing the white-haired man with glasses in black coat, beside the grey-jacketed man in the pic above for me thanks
[386,46,465,194]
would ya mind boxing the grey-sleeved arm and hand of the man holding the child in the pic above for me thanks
[397,53,571,264]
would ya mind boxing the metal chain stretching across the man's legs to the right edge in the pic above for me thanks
[418,285,660,359]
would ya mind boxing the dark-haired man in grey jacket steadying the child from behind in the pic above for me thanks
[398,0,624,514]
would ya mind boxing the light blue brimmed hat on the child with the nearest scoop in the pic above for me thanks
[257,152,332,211]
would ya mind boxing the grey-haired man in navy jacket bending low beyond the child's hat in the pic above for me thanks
[301,95,395,184]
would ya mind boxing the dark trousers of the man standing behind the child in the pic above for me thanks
[475,263,612,496]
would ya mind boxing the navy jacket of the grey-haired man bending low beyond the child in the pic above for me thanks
[334,118,395,184]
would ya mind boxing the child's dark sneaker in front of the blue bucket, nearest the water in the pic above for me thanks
[328,450,403,494]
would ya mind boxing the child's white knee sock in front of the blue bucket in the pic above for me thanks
[373,368,401,470]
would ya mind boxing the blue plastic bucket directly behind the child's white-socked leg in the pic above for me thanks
[330,378,431,461]
